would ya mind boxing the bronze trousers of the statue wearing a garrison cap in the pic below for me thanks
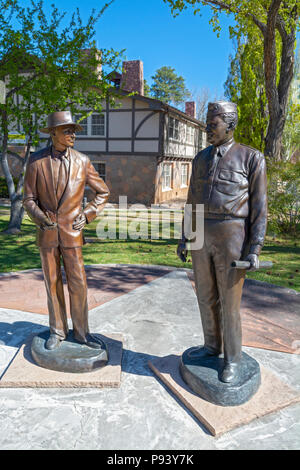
[191,219,247,363]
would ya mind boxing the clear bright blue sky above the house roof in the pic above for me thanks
[22,0,239,98]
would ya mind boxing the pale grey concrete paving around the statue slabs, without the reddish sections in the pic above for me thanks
[0,270,300,451]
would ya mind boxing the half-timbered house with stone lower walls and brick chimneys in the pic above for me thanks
[1,61,206,205]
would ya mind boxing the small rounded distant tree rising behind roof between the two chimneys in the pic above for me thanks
[150,66,190,105]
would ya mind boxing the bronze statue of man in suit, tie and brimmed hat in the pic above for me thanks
[23,111,109,350]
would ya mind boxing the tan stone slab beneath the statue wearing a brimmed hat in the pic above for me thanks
[0,334,123,388]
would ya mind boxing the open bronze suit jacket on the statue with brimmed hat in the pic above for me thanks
[23,147,109,248]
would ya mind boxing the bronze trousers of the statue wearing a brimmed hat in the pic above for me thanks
[40,246,89,341]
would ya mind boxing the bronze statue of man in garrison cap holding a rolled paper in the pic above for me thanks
[177,101,267,383]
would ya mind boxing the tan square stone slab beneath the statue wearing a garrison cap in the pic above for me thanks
[149,355,300,436]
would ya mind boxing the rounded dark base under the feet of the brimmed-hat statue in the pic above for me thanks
[31,331,108,373]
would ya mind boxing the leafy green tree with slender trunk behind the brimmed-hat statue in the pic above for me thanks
[0,0,123,234]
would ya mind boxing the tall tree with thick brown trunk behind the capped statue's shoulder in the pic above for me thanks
[164,0,300,160]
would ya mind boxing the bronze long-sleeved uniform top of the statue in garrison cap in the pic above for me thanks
[187,141,267,254]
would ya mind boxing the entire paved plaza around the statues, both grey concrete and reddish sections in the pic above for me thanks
[0,265,300,450]
